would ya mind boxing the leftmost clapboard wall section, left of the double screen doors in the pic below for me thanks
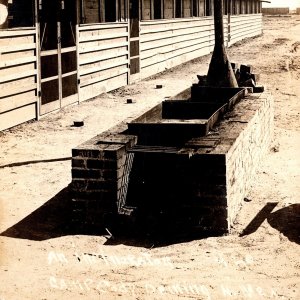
[0,28,38,130]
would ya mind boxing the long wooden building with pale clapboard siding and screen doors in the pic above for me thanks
[0,0,262,130]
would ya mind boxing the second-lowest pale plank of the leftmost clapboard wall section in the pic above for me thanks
[0,90,37,114]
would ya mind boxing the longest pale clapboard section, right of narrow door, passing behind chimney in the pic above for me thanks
[140,16,228,78]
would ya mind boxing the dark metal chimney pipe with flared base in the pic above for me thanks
[207,0,238,87]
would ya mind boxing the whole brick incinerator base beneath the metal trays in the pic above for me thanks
[72,92,274,233]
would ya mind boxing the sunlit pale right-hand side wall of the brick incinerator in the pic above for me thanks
[225,93,274,225]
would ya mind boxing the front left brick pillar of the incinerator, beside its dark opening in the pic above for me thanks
[71,127,136,225]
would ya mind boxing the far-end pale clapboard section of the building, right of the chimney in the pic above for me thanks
[229,14,262,46]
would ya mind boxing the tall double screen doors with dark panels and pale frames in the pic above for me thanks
[39,0,78,114]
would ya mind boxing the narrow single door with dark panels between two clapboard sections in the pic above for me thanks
[129,0,140,81]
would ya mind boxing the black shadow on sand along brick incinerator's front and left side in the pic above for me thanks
[0,186,218,248]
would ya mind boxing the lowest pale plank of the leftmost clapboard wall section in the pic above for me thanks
[0,103,37,130]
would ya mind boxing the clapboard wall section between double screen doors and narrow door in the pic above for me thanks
[78,23,129,101]
